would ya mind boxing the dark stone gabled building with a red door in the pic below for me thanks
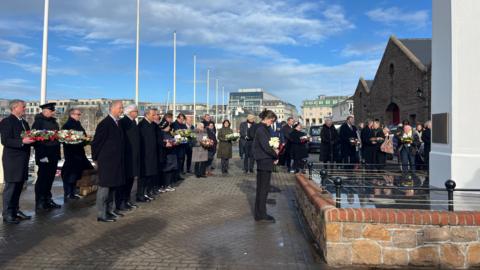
[353,36,432,125]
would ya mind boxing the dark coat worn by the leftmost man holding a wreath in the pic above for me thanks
[0,114,30,183]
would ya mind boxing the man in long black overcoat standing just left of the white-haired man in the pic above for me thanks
[92,101,125,222]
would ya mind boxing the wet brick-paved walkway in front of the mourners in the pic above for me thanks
[0,160,325,269]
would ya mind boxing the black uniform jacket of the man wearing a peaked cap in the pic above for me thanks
[32,113,60,164]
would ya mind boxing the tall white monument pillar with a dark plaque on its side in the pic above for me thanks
[430,0,480,209]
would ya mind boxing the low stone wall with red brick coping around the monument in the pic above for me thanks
[296,174,480,269]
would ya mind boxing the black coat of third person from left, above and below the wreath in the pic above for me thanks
[62,118,93,180]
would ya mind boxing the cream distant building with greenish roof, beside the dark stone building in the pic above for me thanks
[302,95,349,126]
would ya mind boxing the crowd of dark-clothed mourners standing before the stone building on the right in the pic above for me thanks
[320,116,431,174]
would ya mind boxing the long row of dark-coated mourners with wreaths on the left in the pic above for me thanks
[0,100,240,224]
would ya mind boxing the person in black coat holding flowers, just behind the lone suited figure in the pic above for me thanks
[290,123,308,173]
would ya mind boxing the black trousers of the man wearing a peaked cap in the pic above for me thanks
[35,160,58,203]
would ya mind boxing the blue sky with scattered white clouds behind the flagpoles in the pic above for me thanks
[0,0,432,109]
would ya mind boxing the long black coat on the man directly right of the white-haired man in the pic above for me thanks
[138,118,158,176]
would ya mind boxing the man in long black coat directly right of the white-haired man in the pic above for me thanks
[137,109,158,202]
